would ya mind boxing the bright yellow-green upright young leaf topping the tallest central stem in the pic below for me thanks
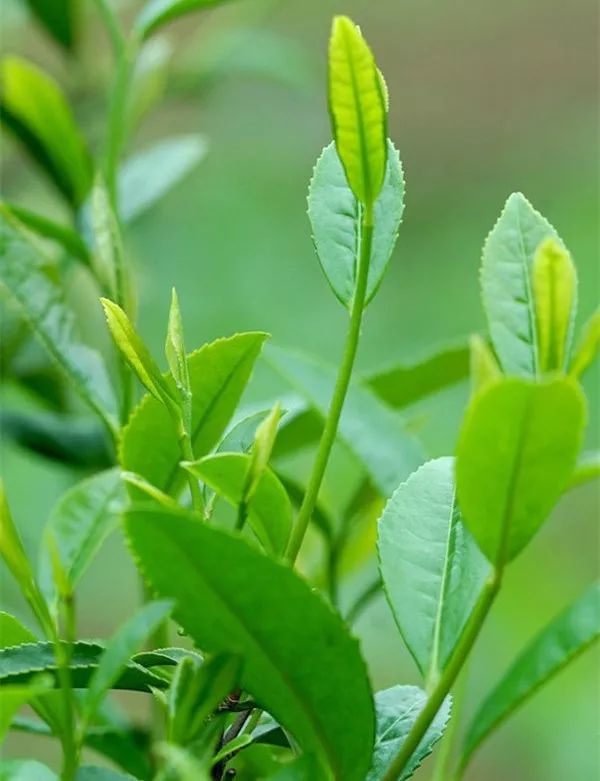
[329,16,387,208]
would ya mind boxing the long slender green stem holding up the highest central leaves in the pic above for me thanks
[286,207,373,564]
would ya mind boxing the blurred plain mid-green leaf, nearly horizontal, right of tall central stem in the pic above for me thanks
[363,342,469,409]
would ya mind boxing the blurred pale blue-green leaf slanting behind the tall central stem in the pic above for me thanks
[267,346,424,496]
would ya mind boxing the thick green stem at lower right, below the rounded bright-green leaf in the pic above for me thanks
[383,569,502,781]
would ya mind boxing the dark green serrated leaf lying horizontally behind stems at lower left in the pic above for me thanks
[0,640,168,691]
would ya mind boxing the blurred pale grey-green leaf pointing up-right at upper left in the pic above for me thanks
[117,135,207,222]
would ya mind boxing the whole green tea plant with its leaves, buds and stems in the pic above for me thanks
[0,6,600,781]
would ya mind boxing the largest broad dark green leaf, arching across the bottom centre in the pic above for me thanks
[125,508,373,781]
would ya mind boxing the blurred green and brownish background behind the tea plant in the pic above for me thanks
[0,0,600,781]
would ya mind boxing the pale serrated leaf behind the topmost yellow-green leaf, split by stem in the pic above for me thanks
[308,140,404,307]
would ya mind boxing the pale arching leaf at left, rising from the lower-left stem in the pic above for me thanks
[39,469,125,596]
